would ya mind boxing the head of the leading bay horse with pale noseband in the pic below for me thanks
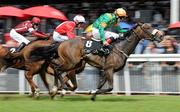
[132,23,164,42]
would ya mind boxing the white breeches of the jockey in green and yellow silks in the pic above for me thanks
[92,28,119,40]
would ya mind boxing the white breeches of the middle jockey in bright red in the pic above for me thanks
[53,31,69,42]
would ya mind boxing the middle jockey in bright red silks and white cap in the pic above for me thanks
[53,15,86,42]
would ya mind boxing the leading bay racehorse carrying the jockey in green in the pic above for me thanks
[23,22,163,100]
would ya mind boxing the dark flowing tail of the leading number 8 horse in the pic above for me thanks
[29,43,60,61]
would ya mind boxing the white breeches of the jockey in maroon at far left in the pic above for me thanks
[10,29,30,44]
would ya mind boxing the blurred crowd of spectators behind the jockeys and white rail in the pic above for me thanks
[0,1,180,60]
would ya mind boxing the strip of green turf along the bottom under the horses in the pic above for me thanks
[0,95,180,112]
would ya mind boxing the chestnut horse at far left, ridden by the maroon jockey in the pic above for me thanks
[0,40,77,98]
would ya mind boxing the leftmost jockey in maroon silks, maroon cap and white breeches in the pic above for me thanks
[10,17,49,52]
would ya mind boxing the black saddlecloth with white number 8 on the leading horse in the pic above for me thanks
[84,39,113,56]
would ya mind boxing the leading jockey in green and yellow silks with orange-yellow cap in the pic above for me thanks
[92,8,127,46]
